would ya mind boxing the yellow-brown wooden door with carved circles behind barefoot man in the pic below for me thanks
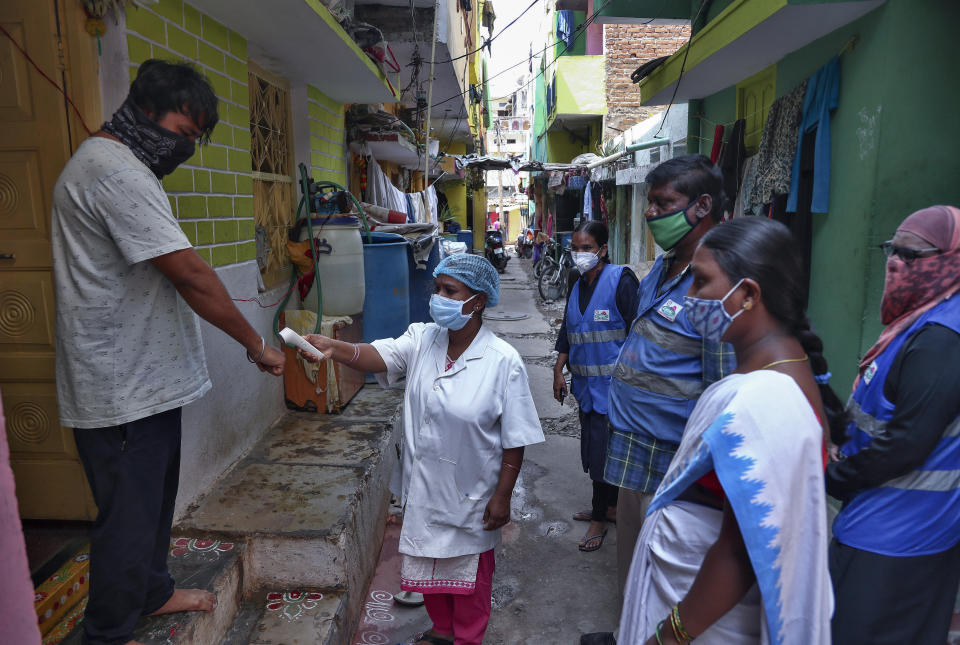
[0,0,98,519]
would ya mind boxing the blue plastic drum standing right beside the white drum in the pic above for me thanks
[363,233,410,343]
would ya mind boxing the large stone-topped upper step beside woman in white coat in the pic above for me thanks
[175,387,402,643]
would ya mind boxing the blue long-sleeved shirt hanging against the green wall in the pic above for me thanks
[787,56,840,213]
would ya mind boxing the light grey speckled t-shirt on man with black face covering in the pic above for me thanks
[51,137,210,428]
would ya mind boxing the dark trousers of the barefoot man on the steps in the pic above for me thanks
[73,408,180,645]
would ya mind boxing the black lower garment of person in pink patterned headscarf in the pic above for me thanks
[830,540,960,645]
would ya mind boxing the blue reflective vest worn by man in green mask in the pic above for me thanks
[608,256,704,443]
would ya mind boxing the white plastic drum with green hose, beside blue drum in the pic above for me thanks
[300,217,365,316]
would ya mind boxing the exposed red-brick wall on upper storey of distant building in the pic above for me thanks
[603,25,690,140]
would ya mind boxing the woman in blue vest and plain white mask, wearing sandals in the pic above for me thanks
[553,221,639,551]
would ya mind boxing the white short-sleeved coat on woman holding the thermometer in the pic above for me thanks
[372,323,543,558]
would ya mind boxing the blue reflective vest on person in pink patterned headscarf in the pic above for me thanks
[833,296,960,556]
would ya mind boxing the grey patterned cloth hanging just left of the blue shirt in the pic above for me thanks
[744,81,807,209]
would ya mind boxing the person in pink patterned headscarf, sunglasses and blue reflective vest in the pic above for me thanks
[827,206,960,645]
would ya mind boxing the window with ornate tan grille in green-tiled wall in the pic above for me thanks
[248,63,294,286]
